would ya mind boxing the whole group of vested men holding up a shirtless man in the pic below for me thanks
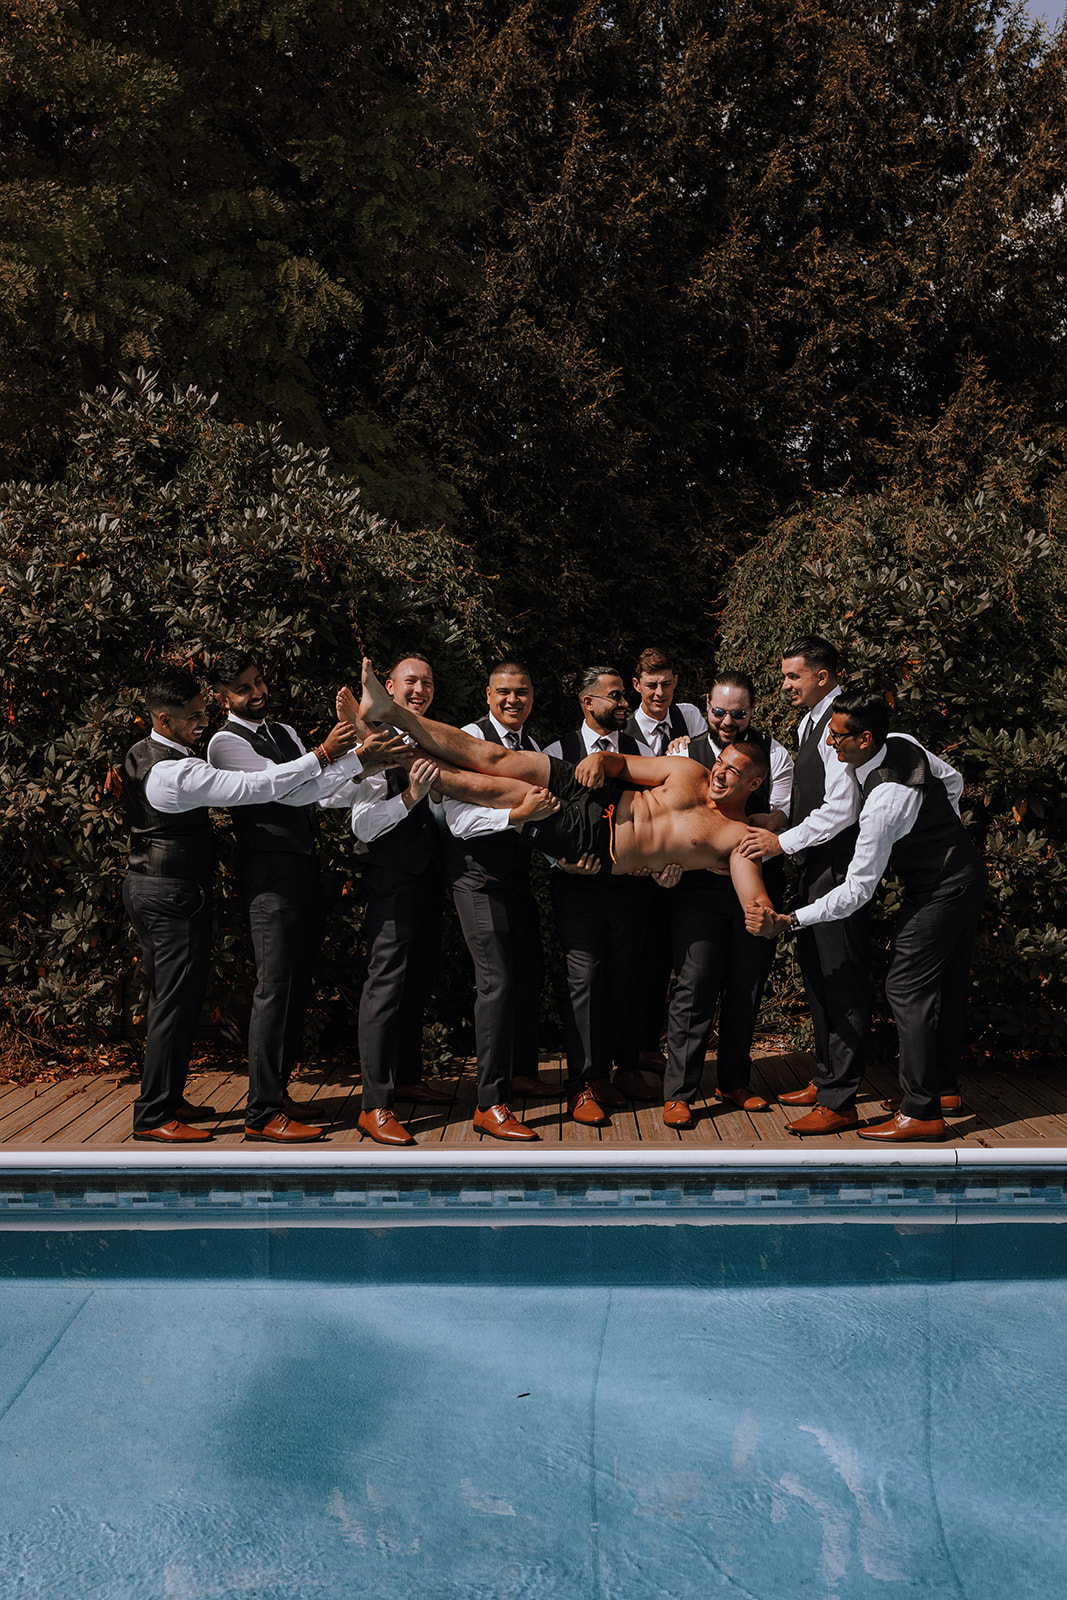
[123,635,985,1147]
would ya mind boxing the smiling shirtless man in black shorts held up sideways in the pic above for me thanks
[338,661,771,907]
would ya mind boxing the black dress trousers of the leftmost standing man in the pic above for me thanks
[122,872,211,1133]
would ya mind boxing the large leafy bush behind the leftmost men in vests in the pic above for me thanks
[0,374,494,1027]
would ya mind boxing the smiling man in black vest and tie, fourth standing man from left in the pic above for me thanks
[445,661,558,1139]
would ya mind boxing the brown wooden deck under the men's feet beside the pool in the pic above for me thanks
[0,1053,1067,1165]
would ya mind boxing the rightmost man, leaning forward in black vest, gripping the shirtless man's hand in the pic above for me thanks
[745,690,987,1144]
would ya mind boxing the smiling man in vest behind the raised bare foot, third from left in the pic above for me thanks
[352,654,454,1146]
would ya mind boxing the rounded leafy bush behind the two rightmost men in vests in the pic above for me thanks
[720,446,1067,1051]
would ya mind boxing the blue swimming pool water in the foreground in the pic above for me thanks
[0,1181,1067,1600]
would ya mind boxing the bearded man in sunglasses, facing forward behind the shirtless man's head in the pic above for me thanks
[664,672,793,1128]
